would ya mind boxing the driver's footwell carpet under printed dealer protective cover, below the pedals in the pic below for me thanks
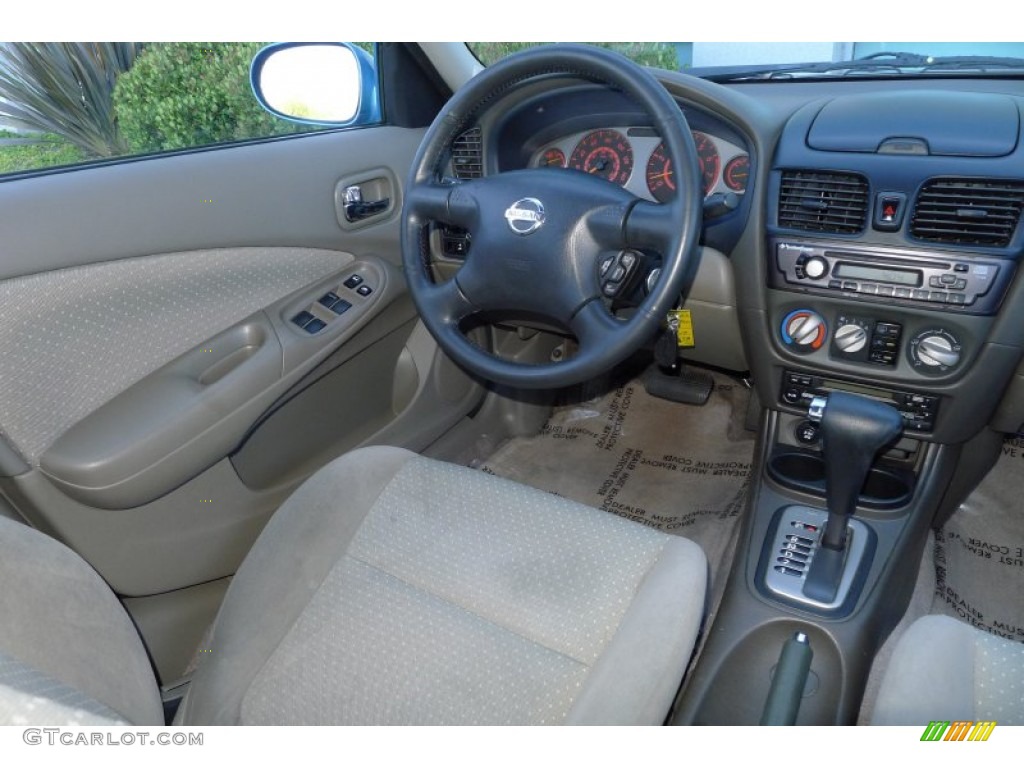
[480,374,755,587]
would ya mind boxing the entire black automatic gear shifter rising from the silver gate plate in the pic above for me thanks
[804,392,903,603]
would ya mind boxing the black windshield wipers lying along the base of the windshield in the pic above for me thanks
[691,51,1024,83]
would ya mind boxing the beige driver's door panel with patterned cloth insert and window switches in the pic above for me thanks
[0,127,482,606]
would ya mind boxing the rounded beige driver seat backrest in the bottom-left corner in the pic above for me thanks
[0,517,164,725]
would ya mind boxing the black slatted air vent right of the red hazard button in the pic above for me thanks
[910,178,1024,248]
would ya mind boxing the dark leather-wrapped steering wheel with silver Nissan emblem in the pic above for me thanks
[401,45,703,389]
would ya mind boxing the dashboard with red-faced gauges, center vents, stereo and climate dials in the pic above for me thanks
[445,74,1024,450]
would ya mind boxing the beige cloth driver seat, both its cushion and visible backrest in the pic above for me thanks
[0,447,707,725]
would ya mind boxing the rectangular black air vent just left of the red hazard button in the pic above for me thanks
[778,170,867,234]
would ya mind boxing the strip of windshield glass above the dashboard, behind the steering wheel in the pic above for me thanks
[468,42,1024,80]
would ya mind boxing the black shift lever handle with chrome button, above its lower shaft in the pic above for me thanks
[809,392,903,550]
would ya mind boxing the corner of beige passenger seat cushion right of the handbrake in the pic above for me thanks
[871,615,1024,725]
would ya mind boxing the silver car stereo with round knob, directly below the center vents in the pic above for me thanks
[772,240,1014,314]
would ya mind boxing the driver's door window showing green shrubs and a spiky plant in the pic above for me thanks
[0,43,380,179]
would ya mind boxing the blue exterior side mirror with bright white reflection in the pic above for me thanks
[249,43,381,126]
